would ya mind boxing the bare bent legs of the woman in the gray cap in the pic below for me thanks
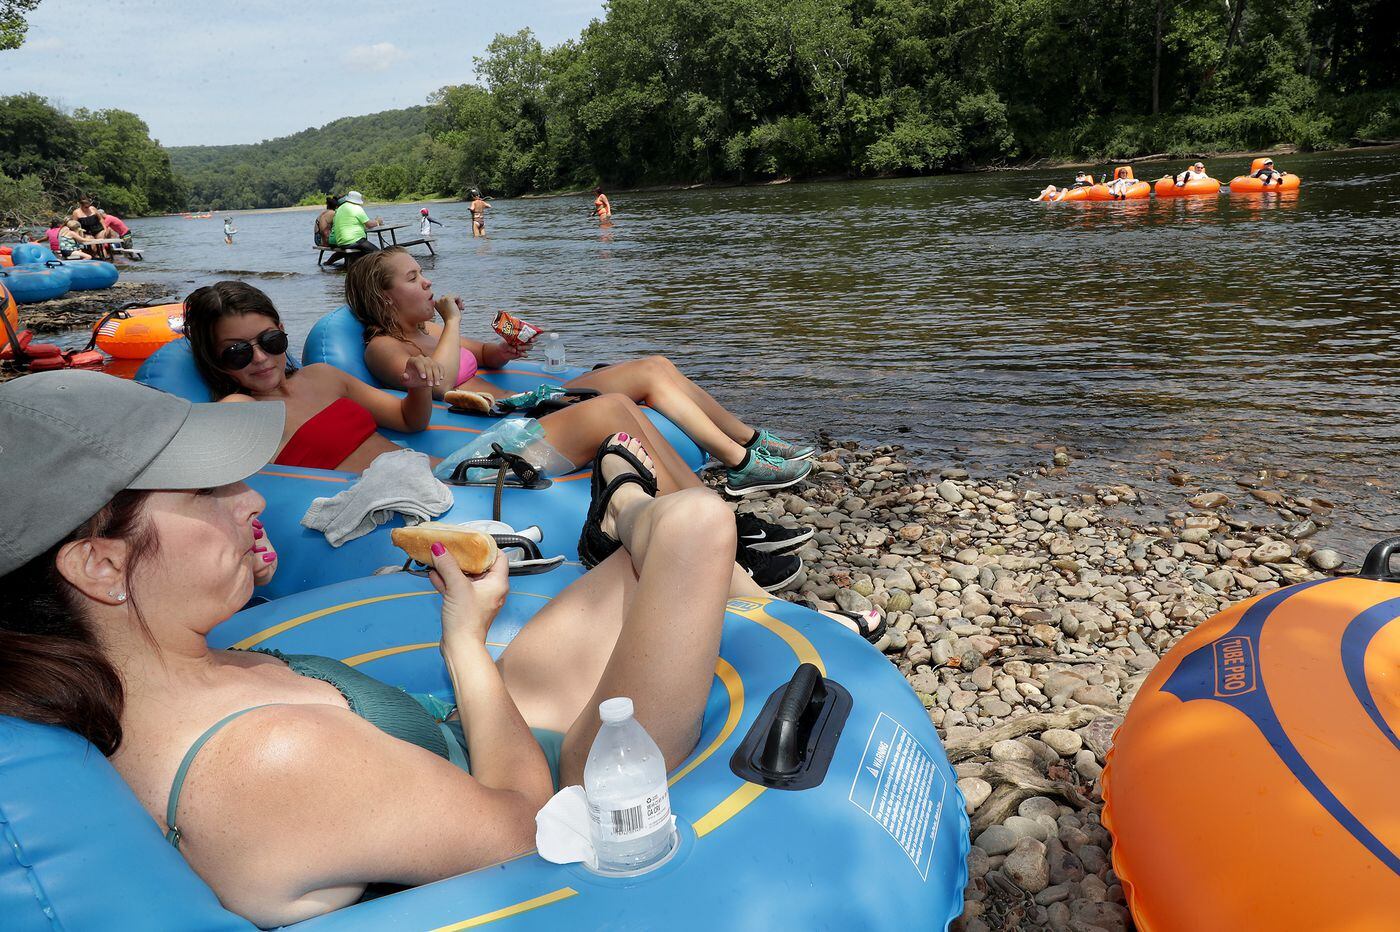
[498,436,735,784]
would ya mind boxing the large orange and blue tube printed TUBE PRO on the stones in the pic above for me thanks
[1103,537,1400,932]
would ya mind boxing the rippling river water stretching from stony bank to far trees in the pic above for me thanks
[90,150,1400,556]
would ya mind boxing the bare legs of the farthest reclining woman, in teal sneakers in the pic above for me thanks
[568,355,753,466]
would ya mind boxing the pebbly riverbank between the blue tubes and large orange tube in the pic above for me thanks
[722,439,1343,932]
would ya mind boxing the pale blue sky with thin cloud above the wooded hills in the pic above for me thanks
[0,0,602,146]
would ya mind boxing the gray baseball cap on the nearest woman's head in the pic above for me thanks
[0,371,286,575]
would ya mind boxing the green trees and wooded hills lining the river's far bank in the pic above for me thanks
[0,0,1383,213]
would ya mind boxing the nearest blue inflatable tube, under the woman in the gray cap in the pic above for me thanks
[0,571,969,932]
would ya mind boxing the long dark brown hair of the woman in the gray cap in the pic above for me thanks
[0,491,158,757]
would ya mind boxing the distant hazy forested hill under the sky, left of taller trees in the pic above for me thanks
[167,106,445,210]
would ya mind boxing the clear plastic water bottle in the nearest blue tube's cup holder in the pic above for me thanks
[584,697,675,873]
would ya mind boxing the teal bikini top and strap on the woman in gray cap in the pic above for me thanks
[165,651,470,848]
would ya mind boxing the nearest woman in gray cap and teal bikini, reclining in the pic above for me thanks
[0,372,739,926]
